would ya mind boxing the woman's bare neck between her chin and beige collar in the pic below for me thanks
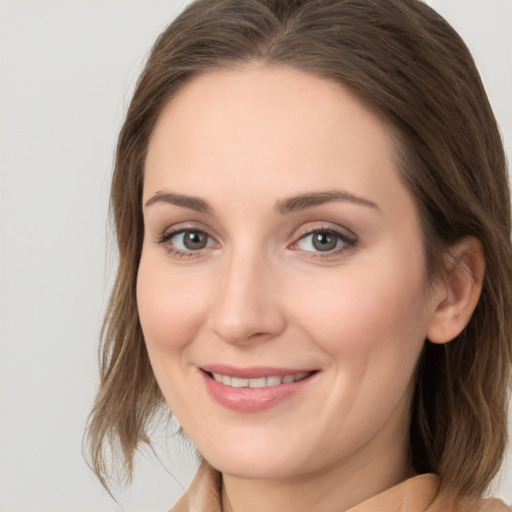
[222,436,413,512]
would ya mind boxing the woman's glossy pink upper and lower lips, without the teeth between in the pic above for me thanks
[201,365,315,412]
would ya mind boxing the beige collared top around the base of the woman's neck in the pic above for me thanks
[169,463,512,512]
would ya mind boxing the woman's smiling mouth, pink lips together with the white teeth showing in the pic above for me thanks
[201,365,318,413]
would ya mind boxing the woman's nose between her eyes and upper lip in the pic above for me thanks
[208,250,286,344]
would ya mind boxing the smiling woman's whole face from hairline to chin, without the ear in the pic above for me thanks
[137,65,438,478]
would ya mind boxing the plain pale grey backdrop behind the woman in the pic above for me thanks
[0,0,512,512]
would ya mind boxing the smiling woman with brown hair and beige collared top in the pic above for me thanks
[89,0,512,512]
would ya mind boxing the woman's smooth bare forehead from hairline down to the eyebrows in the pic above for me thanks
[144,64,406,216]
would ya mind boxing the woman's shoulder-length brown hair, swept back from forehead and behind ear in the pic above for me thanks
[88,0,512,496]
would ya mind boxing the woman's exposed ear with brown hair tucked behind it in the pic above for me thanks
[427,236,485,343]
